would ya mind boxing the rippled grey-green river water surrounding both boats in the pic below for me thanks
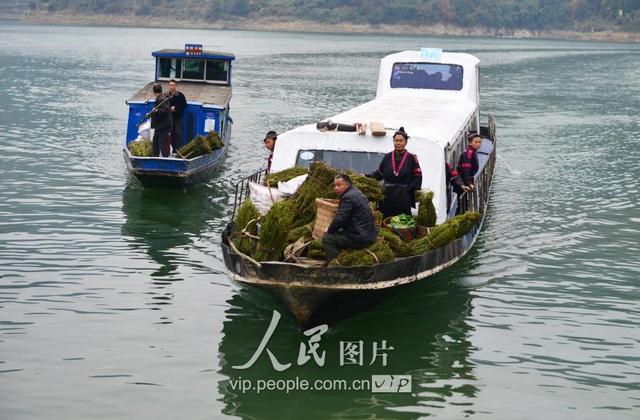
[0,22,640,419]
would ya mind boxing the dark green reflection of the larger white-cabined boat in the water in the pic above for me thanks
[219,264,479,419]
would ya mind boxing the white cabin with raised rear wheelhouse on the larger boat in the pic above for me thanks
[271,49,480,223]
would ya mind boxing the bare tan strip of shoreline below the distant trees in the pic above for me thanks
[20,12,640,43]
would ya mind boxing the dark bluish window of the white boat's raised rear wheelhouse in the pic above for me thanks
[391,63,463,90]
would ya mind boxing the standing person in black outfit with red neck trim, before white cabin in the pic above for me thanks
[368,127,422,218]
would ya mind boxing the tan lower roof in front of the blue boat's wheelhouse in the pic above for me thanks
[127,82,231,108]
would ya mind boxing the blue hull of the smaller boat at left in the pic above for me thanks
[122,139,227,188]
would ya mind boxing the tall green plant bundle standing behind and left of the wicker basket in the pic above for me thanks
[294,161,338,227]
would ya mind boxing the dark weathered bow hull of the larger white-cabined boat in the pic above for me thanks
[222,213,483,326]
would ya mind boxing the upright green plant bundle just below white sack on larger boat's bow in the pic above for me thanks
[255,200,296,261]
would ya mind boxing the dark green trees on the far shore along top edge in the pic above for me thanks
[29,0,640,31]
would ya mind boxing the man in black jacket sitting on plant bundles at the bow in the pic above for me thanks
[322,174,378,264]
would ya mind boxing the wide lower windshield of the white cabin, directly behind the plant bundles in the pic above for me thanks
[296,150,384,174]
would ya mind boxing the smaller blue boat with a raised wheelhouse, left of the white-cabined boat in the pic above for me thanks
[122,44,235,188]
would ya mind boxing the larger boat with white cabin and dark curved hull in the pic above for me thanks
[222,49,497,325]
